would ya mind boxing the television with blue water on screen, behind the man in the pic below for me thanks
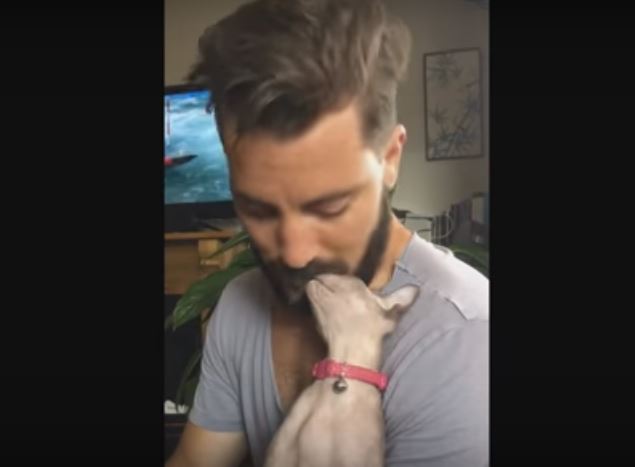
[164,85,236,232]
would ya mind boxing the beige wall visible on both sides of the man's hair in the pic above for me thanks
[165,0,489,218]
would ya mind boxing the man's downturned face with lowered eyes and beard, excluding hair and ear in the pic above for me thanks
[229,105,398,305]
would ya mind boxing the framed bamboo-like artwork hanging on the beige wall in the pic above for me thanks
[423,48,483,161]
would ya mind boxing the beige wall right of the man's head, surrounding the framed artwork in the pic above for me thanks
[386,0,489,218]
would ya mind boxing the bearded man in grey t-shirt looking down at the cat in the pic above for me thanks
[168,0,489,467]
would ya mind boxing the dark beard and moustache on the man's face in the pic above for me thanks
[252,189,390,313]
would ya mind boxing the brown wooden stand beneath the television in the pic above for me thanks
[164,229,239,295]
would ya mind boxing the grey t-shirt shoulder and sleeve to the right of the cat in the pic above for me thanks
[383,237,489,465]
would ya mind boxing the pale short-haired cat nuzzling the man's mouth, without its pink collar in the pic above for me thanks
[265,274,419,467]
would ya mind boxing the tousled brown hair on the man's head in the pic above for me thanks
[188,0,410,151]
